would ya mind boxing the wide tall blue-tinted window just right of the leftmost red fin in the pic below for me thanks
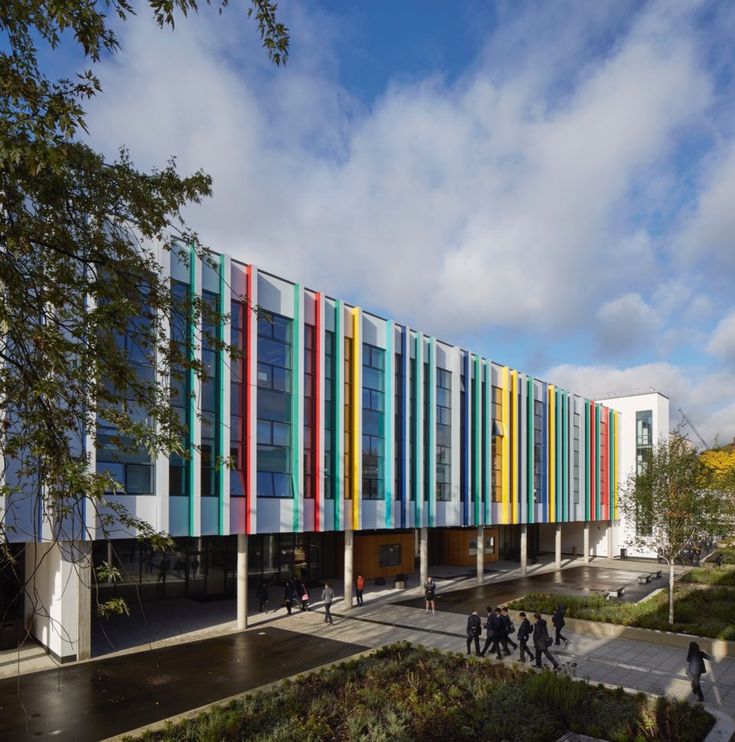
[257,314,293,497]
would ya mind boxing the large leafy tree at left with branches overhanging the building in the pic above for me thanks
[0,0,289,628]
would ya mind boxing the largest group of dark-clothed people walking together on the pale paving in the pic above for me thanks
[467,606,569,670]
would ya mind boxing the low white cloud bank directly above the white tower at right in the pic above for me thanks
[545,363,735,445]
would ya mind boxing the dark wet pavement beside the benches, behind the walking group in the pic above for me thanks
[394,566,667,615]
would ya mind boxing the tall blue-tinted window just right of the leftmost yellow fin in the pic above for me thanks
[362,343,385,500]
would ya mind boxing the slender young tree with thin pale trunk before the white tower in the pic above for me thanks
[620,434,729,624]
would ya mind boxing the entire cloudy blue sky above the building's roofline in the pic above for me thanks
[77,0,735,442]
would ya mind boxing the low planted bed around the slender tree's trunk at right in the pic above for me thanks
[508,585,735,640]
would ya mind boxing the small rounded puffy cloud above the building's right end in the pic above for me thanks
[596,293,661,356]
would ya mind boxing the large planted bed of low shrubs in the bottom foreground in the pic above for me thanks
[128,643,713,742]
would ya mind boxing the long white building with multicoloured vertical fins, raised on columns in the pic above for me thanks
[6,253,665,661]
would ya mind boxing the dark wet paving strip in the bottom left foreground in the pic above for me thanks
[0,626,368,742]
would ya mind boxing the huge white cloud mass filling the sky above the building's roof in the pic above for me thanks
[90,0,710,336]
